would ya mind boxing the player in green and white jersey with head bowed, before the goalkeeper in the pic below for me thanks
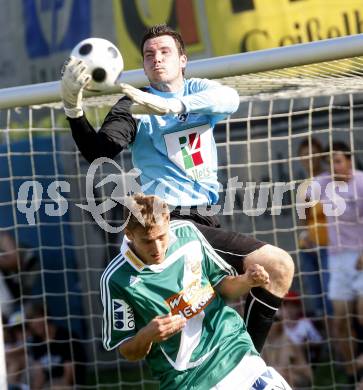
[101,194,291,390]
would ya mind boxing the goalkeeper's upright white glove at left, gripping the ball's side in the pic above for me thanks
[61,56,91,118]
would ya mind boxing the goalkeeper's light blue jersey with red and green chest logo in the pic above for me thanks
[131,78,239,206]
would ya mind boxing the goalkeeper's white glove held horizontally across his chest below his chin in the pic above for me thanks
[119,83,185,115]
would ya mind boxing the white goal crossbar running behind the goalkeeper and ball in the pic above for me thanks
[0,34,363,109]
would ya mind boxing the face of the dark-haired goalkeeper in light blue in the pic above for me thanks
[143,35,187,92]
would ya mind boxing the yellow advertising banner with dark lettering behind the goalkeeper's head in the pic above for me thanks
[114,0,363,69]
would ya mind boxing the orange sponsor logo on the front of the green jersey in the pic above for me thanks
[166,280,215,319]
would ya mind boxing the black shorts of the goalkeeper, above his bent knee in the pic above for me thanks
[170,207,266,274]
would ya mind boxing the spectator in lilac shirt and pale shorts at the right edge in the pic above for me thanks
[318,142,363,377]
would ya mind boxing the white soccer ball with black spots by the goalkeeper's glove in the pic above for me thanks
[71,38,124,92]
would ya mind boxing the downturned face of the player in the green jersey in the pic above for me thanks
[126,223,169,264]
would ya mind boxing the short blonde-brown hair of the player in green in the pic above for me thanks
[125,193,170,231]
